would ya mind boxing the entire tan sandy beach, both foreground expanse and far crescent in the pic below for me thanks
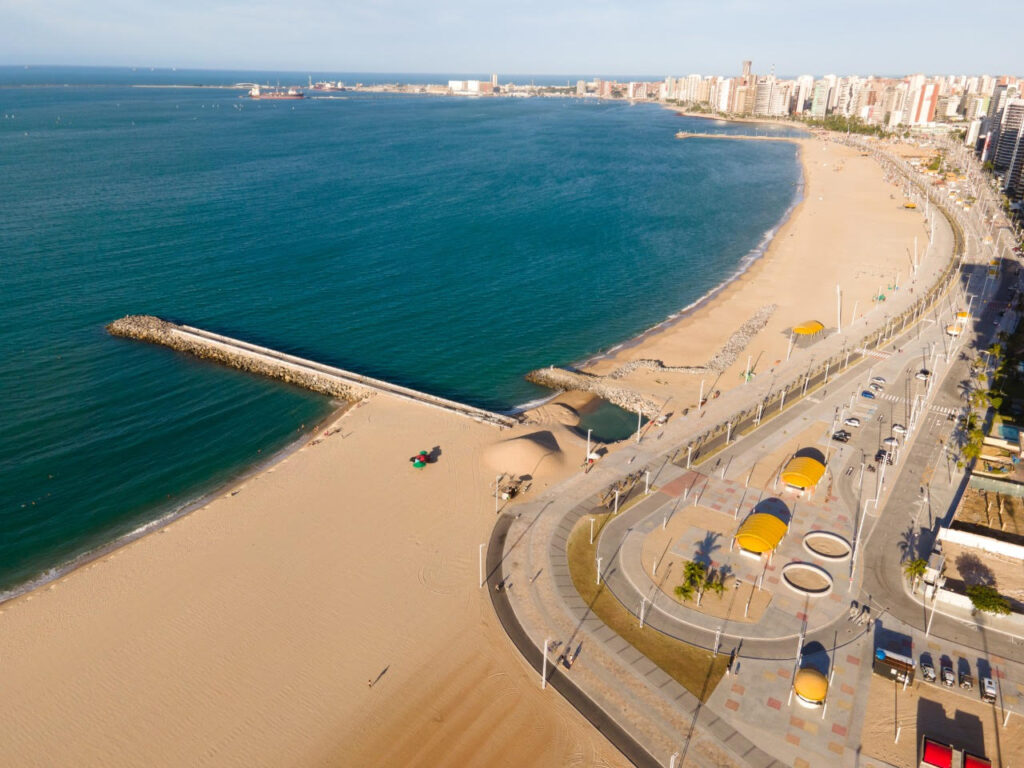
[0,129,927,768]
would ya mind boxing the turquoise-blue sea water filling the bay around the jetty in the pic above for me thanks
[0,68,800,590]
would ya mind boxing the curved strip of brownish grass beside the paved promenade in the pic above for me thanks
[566,515,729,701]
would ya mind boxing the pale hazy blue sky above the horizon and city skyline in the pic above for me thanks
[0,0,1024,75]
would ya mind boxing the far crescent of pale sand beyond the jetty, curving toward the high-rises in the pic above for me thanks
[587,138,928,411]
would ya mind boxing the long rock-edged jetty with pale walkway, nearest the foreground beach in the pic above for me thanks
[106,314,519,428]
